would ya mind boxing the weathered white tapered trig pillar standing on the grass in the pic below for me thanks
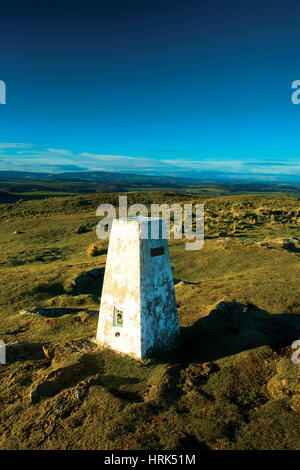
[97,217,179,359]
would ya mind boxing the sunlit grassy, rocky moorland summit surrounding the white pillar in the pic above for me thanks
[0,191,300,450]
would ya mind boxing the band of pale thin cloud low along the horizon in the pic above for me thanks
[0,143,300,181]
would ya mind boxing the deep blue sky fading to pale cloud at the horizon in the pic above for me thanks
[0,0,300,182]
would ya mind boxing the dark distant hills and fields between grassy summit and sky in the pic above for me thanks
[0,171,300,203]
